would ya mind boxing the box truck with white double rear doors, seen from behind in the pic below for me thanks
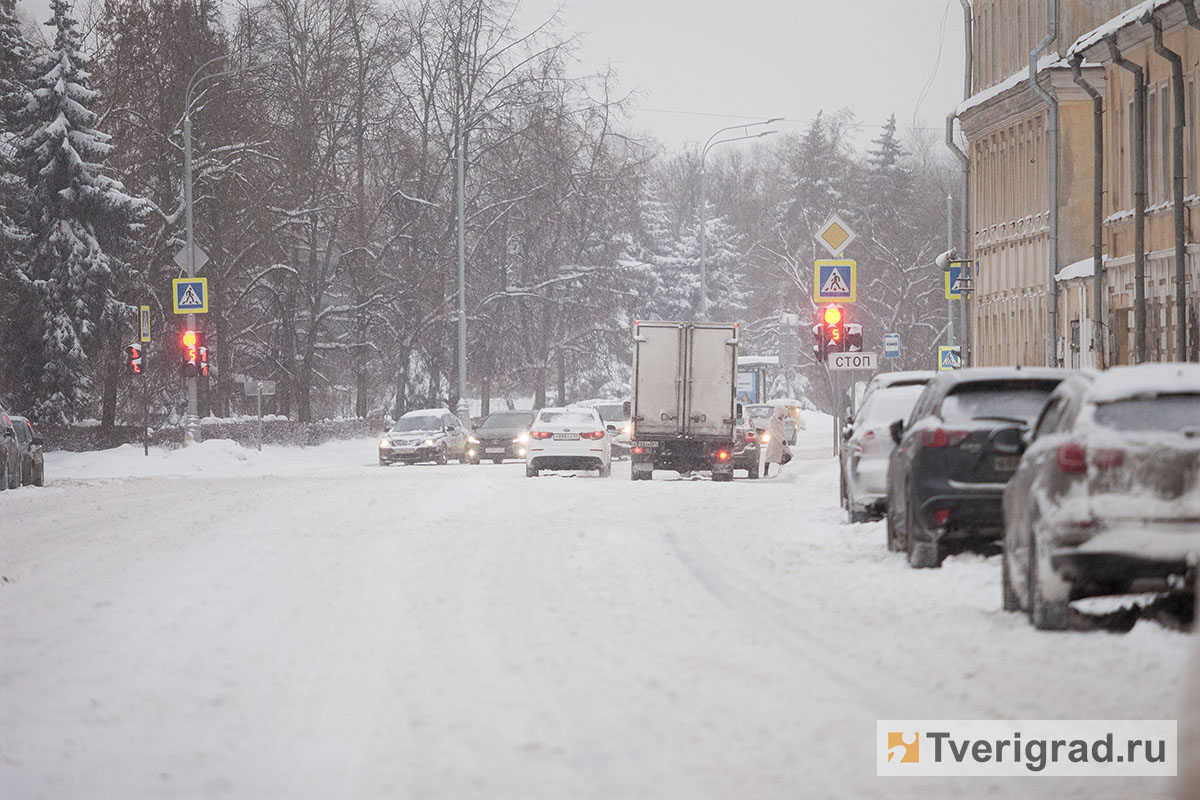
[630,321,738,481]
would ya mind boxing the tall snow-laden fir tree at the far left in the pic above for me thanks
[14,0,145,421]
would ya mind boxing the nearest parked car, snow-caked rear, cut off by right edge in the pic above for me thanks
[1003,363,1200,630]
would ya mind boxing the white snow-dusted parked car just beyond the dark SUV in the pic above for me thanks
[841,383,925,522]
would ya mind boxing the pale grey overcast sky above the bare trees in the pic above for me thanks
[19,0,964,146]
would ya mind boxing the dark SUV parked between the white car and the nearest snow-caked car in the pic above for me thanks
[887,367,1070,567]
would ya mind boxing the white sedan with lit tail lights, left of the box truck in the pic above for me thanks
[526,408,612,477]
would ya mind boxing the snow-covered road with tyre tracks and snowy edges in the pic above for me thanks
[0,414,1200,799]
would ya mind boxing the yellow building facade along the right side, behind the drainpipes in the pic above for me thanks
[958,0,1200,366]
